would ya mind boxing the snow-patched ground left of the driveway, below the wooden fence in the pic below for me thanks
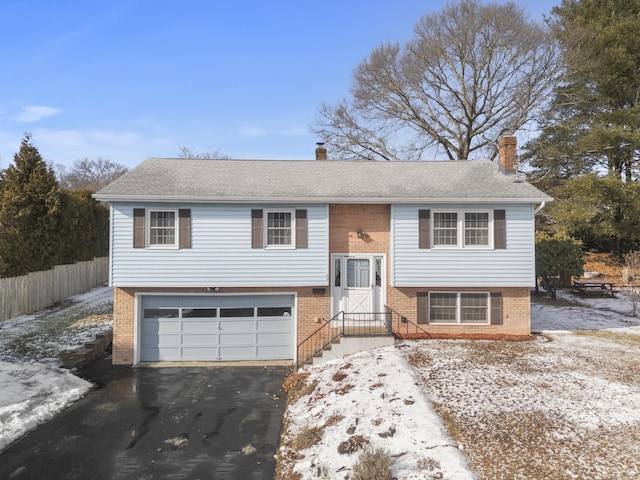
[0,287,113,452]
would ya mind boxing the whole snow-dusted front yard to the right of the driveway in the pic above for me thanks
[279,292,640,480]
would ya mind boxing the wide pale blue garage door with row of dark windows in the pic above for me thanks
[139,295,295,362]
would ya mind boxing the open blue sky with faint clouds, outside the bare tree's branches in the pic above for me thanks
[0,0,560,168]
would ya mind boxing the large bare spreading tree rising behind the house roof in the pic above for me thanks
[312,0,562,160]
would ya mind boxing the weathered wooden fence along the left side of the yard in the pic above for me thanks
[0,257,109,322]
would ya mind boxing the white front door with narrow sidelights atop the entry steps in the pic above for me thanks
[332,255,384,315]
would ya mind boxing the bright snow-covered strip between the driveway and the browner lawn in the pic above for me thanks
[280,347,474,480]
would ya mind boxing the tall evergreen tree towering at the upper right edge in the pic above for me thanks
[527,0,640,182]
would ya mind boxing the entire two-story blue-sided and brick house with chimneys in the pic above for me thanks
[95,136,551,364]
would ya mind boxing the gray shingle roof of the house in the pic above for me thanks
[95,158,551,203]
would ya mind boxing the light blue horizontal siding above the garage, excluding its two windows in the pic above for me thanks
[111,203,329,287]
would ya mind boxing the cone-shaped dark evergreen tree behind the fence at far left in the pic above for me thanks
[0,134,60,277]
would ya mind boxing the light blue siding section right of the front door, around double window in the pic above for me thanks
[390,204,535,287]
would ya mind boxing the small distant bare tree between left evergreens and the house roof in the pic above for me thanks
[57,157,128,192]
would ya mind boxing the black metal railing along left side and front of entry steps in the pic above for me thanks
[297,311,392,368]
